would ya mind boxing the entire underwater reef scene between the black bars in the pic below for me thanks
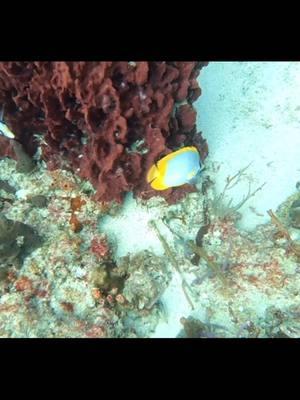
[0,61,300,339]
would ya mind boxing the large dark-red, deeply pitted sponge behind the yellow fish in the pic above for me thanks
[0,61,208,203]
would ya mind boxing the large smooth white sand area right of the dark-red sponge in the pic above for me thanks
[195,62,300,229]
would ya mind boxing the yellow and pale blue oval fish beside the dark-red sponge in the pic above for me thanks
[147,146,202,190]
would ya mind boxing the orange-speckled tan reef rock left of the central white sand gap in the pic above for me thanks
[0,159,170,338]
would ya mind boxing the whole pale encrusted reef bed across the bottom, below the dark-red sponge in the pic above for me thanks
[0,144,300,338]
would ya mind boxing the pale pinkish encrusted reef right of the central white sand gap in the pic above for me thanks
[148,163,300,338]
